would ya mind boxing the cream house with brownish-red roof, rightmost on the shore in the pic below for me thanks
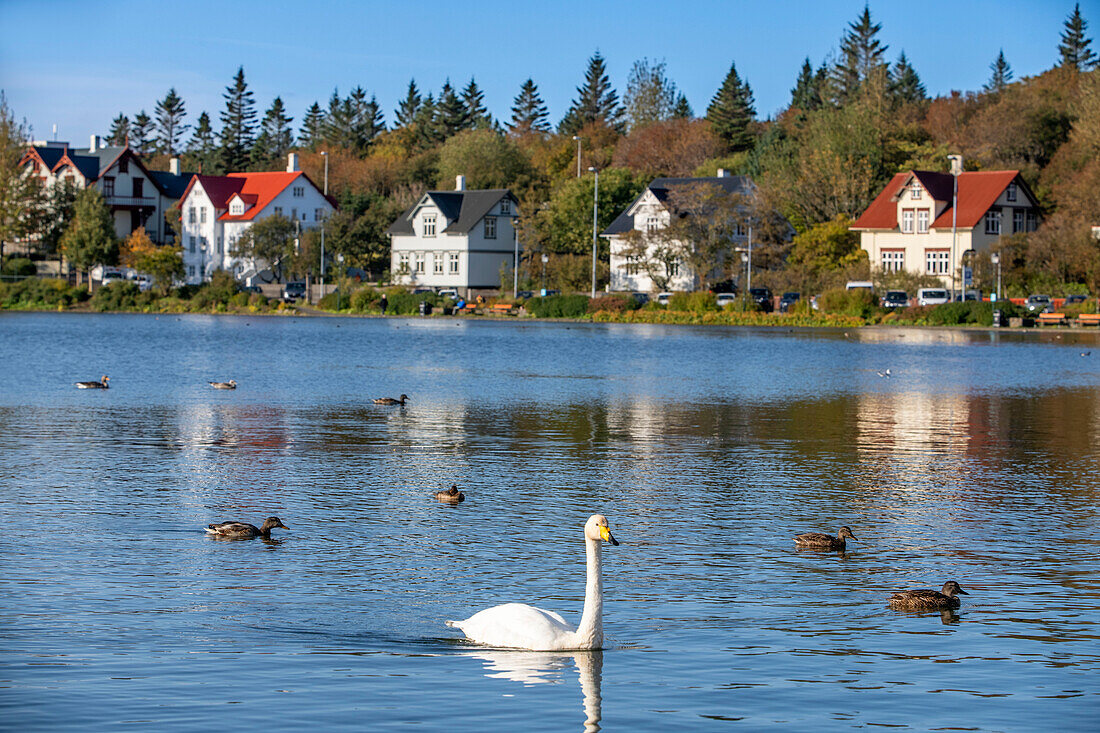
[850,162,1040,286]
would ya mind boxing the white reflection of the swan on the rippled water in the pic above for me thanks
[466,649,604,733]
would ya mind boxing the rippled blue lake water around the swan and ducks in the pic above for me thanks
[0,314,1100,733]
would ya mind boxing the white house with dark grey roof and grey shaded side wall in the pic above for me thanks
[386,176,519,295]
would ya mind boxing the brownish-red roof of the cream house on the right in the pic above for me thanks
[851,171,1032,229]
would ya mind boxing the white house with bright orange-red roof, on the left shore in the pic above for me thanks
[179,153,336,284]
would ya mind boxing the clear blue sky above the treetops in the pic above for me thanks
[0,0,1100,144]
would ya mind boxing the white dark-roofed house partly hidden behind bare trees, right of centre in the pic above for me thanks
[601,168,756,293]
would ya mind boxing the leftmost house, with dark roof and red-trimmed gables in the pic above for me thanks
[20,135,191,243]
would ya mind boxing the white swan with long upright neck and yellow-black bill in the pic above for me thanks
[447,514,618,652]
